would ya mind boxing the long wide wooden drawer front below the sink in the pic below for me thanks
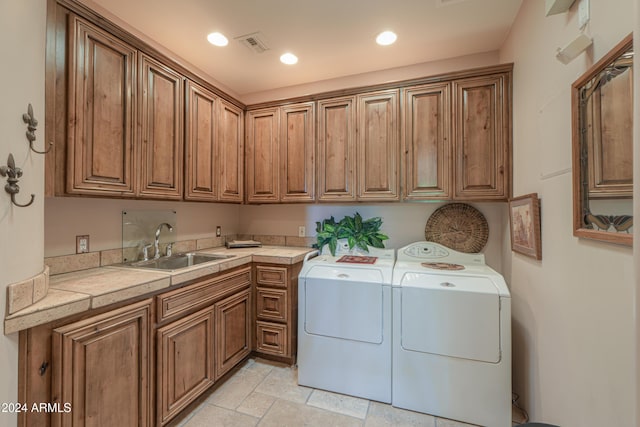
[156,267,251,323]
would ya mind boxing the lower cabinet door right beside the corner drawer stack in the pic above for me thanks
[215,289,251,379]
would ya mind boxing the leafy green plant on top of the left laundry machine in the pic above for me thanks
[314,212,389,256]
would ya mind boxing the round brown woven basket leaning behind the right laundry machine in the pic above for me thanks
[424,203,489,253]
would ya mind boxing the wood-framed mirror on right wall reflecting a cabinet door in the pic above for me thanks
[571,34,633,246]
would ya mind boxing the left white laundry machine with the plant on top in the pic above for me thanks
[298,242,395,403]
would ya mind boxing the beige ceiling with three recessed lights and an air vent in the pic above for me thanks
[87,0,522,96]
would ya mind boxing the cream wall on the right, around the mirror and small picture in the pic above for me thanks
[500,0,638,427]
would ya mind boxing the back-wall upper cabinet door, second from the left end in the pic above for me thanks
[280,102,315,202]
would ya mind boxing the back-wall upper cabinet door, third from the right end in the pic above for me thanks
[357,90,400,201]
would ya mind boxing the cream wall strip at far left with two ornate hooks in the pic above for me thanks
[0,0,46,426]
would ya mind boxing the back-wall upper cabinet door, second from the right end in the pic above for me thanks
[401,83,453,200]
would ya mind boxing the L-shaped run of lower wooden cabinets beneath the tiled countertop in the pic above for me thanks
[18,263,302,427]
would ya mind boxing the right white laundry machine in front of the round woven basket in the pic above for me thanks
[392,242,511,427]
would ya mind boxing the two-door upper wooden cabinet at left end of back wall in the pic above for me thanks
[245,102,315,203]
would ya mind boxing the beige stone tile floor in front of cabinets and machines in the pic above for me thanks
[180,359,484,427]
